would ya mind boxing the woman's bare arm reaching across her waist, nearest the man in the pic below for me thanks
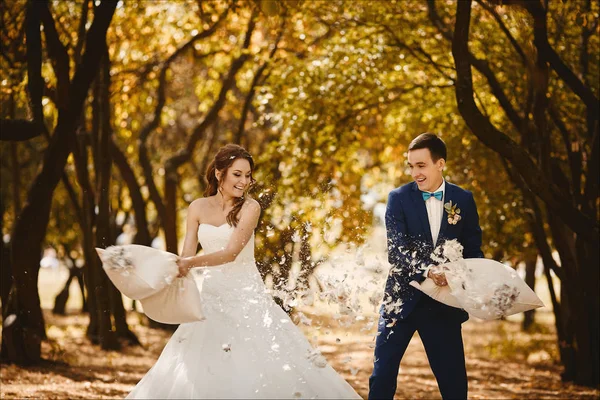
[177,200,260,275]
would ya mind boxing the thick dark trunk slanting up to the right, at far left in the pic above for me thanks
[2,2,116,364]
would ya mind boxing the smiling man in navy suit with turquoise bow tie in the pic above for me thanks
[369,133,483,399]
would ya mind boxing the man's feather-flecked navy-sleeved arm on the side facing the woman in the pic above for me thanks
[385,191,425,283]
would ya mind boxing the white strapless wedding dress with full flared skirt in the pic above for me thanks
[127,224,360,399]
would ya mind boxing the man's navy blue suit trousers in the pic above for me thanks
[369,295,468,400]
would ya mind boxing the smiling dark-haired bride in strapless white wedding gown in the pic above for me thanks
[127,144,360,399]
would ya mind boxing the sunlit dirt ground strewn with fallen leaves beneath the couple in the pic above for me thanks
[0,309,600,399]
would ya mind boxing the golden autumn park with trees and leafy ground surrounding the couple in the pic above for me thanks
[0,0,600,399]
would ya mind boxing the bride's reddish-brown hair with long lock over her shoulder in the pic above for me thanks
[204,144,256,226]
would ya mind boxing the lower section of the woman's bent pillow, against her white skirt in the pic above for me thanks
[140,273,204,324]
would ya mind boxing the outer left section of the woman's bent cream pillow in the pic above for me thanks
[96,244,179,300]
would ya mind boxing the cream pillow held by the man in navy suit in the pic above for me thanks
[441,258,544,320]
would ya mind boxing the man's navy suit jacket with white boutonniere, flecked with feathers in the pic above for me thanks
[382,181,483,320]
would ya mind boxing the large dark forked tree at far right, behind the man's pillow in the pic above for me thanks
[452,0,600,387]
